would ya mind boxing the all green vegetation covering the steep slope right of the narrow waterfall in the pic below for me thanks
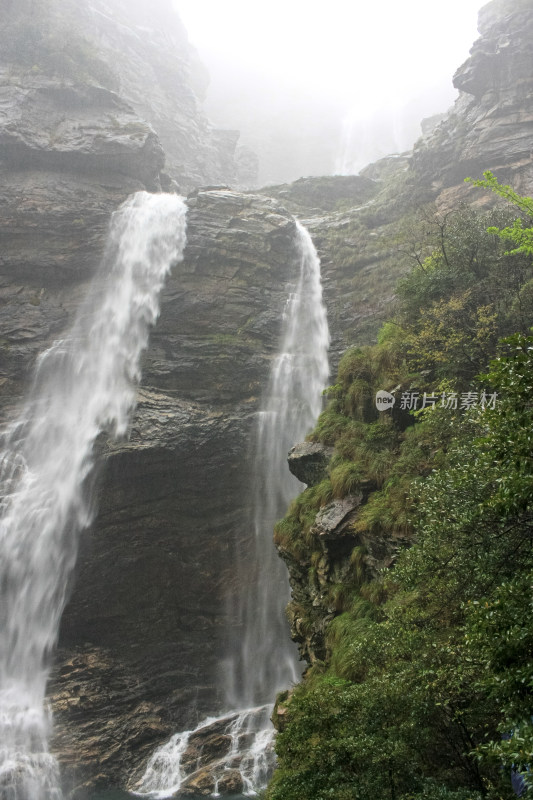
[268,175,533,800]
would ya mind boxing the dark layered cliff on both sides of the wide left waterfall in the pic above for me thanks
[0,120,298,796]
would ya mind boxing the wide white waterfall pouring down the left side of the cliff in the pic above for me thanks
[0,192,186,800]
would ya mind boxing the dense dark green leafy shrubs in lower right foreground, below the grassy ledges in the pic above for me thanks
[274,337,533,800]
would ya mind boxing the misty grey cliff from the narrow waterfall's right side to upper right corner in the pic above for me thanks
[263,0,533,356]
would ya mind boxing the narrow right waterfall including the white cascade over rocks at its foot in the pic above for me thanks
[135,222,329,798]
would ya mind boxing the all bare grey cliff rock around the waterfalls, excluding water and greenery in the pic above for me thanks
[0,0,533,796]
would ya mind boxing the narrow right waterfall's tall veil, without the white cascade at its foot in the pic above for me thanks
[228,217,329,708]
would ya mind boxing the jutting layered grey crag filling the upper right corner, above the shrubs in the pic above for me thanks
[413,0,533,207]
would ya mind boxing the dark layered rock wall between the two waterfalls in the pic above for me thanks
[38,191,297,791]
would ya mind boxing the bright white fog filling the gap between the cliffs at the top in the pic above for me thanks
[174,0,483,184]
